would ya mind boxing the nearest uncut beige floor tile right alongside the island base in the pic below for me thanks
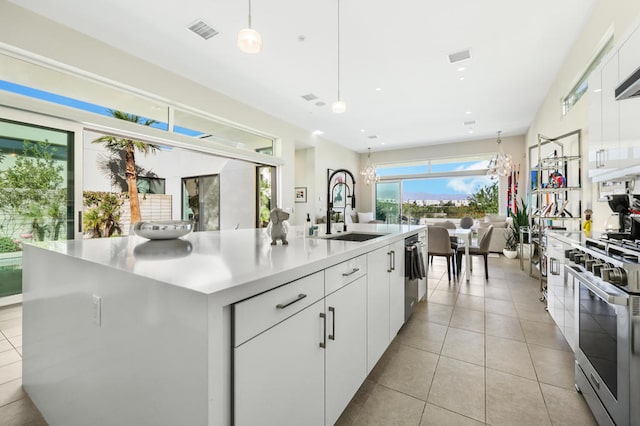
[379,346,438,401]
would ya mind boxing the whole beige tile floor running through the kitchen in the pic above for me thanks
[0,256,596,426]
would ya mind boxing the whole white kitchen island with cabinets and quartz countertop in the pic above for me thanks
[23,225,424,425]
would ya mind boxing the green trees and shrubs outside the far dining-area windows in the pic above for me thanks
[376,181,499,223]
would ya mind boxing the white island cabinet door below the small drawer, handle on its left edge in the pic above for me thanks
[328,277,367,425]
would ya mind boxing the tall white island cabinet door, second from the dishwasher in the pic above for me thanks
[367,247,392,373]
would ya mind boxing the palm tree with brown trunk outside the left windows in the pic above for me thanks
[92,109,158,225]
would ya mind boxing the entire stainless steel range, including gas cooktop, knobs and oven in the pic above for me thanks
[565,238,640,425]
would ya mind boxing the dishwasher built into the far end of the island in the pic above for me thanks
[404,232,427,322]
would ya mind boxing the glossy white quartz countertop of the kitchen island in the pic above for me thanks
[32,224,425,300]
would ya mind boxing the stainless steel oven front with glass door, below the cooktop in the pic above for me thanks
[566,265,640,425]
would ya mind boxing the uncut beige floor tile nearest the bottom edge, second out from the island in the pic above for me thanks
[427,356,485,422]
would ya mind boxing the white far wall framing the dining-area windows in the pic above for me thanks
[357,136,527,214]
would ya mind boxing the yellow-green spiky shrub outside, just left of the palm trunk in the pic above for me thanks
[82,191,125,238]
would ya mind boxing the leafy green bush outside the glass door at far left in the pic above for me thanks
[0,140,67,241]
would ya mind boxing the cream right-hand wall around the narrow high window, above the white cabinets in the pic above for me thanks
[526,0,640,231]
